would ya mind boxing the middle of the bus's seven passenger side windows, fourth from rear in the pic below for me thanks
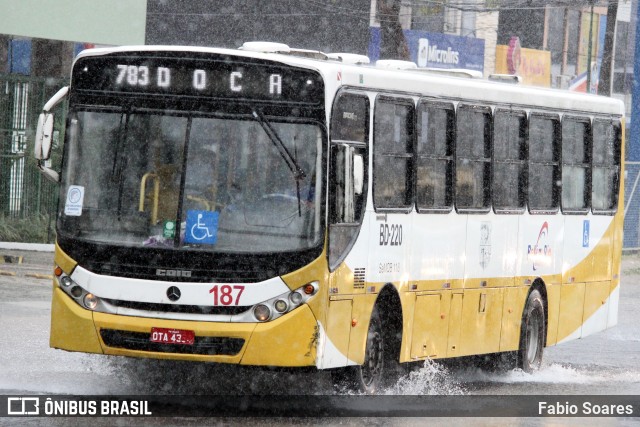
[493,110,527,212]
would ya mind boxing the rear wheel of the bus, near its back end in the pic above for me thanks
[517,289,546,372]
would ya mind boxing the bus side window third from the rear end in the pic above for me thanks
[527,114,560,213]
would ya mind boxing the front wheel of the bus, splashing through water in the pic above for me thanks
[331,306,397,394]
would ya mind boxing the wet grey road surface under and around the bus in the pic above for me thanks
[0,247,640,425]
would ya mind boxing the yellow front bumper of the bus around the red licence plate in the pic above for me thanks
[50,286,318,367]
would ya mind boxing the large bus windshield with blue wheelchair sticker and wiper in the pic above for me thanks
[58,110,323,253]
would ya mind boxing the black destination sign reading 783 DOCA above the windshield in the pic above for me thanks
[71,55,323,104]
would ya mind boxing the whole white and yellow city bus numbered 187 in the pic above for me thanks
[35,42,624,393]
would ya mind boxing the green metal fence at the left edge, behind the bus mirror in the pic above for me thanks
[0,74,67,242]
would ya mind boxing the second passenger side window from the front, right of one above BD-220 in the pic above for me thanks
[416,102,455,212]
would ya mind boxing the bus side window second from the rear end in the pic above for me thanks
[562,117,591,212]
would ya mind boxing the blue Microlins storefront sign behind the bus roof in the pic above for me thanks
[369,27,484,72]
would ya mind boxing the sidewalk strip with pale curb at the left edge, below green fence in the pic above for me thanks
[0,242,54,280]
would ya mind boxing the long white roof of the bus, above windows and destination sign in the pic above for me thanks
[76,45,625,116]
